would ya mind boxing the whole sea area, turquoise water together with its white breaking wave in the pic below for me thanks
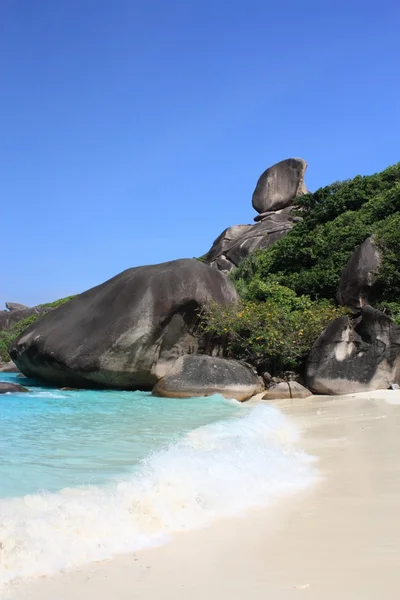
[0,374,315,595]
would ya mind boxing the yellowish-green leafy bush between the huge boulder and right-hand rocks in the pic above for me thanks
[204,279,346,375]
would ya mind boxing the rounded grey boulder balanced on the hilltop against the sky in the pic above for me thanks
[253,158,307,213]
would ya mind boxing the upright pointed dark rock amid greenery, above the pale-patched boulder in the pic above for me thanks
[338,237,381,308]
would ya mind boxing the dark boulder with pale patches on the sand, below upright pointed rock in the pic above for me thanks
[306,306,400,394]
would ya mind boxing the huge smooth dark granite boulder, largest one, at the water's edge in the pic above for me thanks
[10,259,238,390]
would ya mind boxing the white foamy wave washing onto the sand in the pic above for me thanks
[0,405,315,586]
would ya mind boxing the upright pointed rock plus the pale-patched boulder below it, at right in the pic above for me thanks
[306,237,400,394]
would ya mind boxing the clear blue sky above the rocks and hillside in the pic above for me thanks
[0,0,400,304]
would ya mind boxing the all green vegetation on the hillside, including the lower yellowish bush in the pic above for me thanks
[205,163,400,374]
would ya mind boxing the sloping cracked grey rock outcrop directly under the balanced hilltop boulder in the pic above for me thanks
[205,213,295,271]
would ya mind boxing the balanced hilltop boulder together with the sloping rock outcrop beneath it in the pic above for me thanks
[205,158,307,272]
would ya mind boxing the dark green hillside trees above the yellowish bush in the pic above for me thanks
[233,163,400,301]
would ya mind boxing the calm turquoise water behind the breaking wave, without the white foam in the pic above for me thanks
[0,374,243,498]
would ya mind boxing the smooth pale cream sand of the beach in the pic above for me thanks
[7,391,400,600]
